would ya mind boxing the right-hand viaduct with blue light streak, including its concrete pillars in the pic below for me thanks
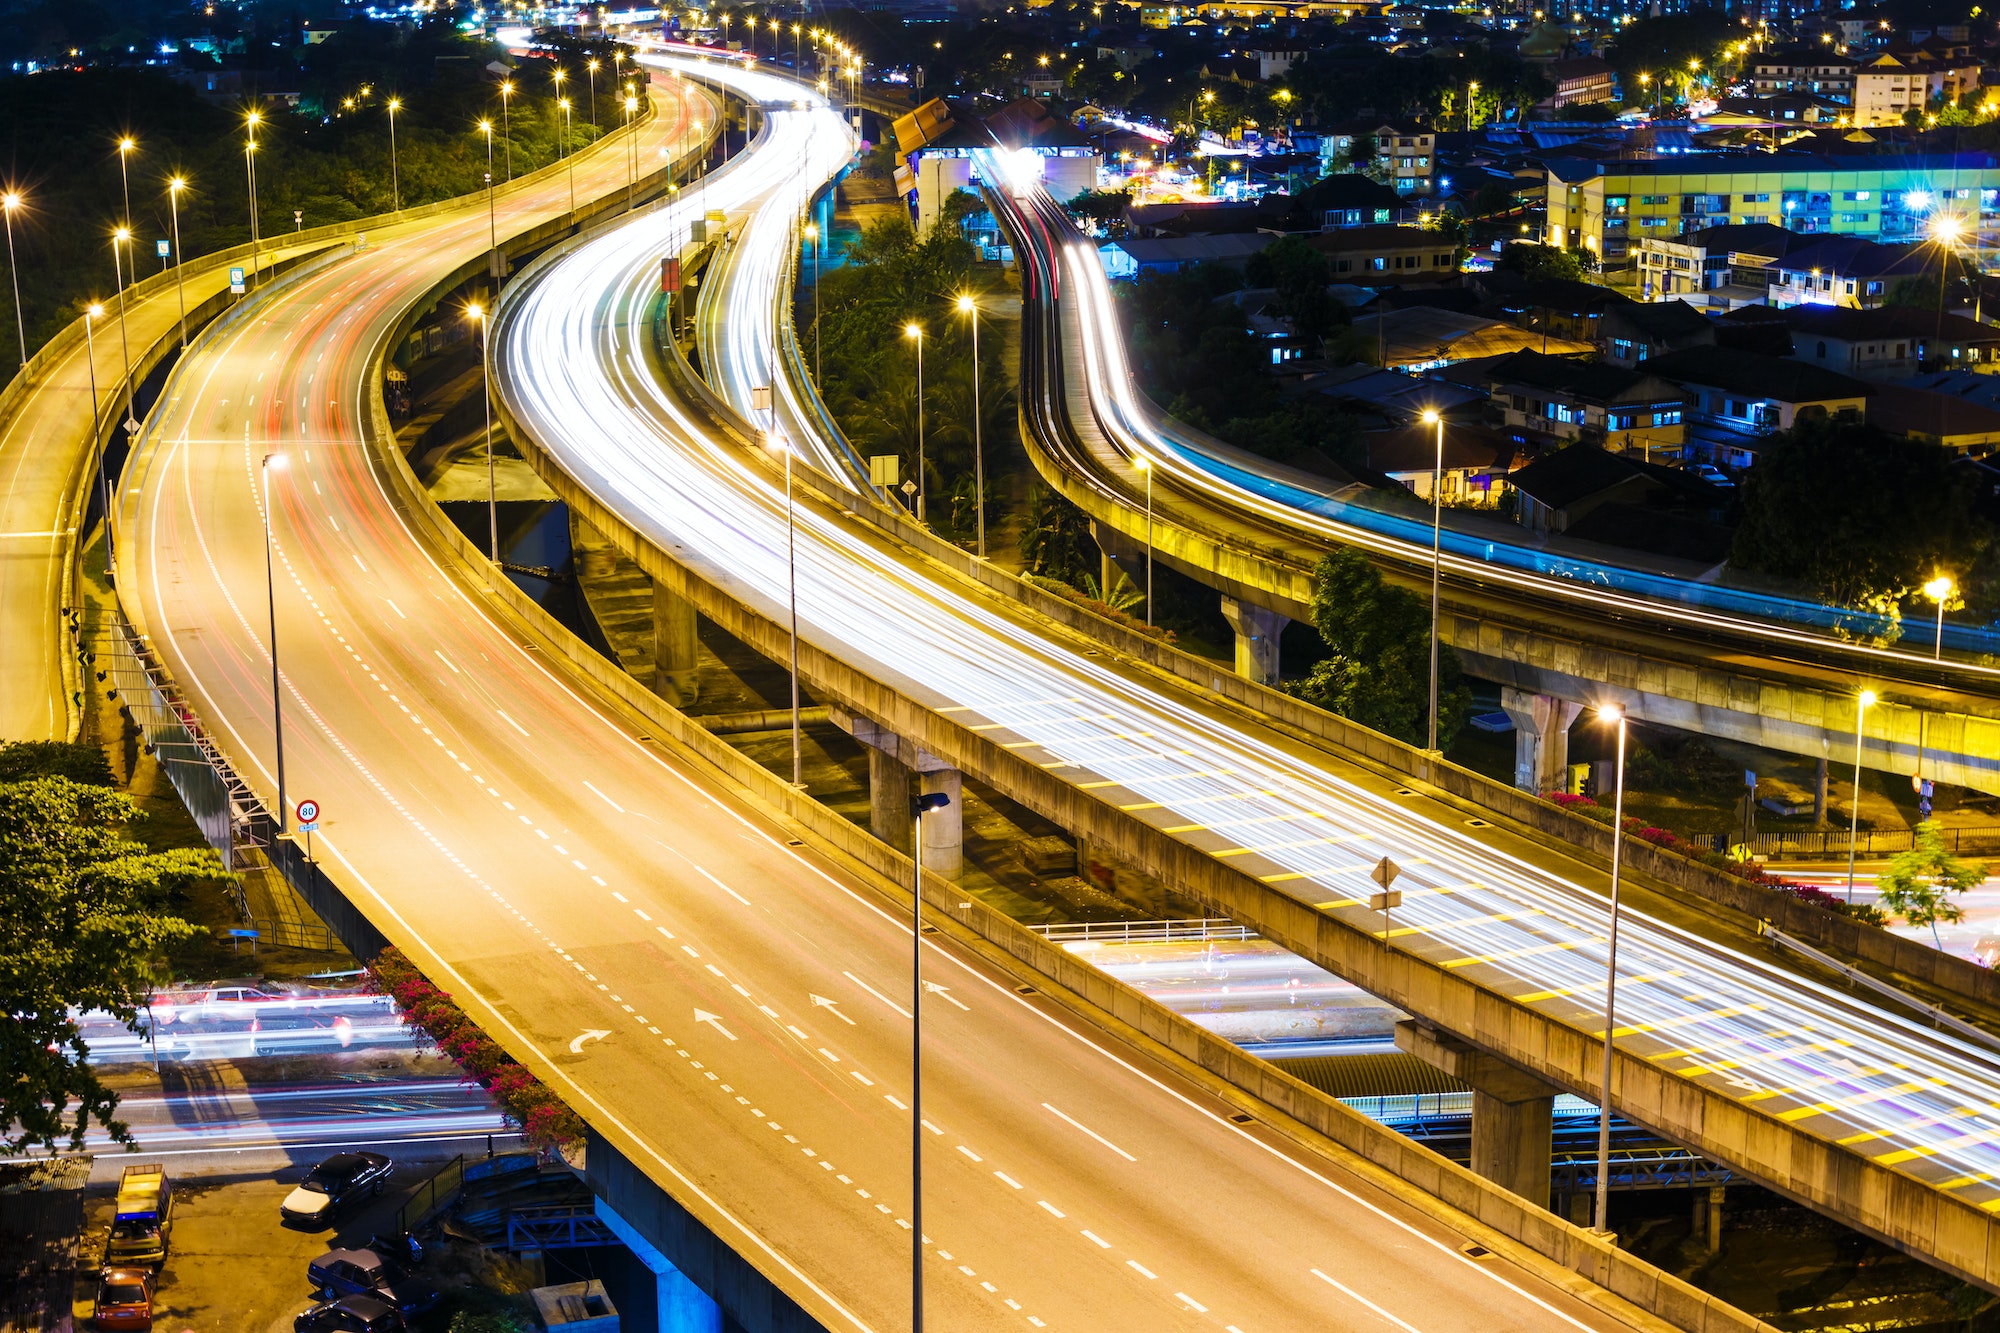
[982,165,2000,791]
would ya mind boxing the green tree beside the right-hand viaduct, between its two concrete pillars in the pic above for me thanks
[1286,546,1472,749]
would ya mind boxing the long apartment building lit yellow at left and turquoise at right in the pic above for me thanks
[1544,150,2000,260]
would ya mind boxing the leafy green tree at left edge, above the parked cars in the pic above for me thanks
[0,772,209,1155]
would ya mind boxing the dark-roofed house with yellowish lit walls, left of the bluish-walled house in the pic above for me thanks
[1444,350,1686,458]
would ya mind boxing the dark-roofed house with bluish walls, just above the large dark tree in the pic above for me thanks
[1646,346,1876,468]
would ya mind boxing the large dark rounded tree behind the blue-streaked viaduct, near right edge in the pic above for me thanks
[1730,420,1994,610]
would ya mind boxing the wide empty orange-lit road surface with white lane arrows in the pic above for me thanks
[113,67,1640,1333]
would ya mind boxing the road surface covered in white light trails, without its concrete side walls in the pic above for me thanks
[496,49,2000,1232]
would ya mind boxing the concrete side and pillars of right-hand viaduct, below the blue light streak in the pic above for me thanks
[994,176,2000,791]
